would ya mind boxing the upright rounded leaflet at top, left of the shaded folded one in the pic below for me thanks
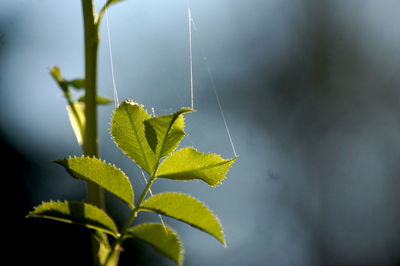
[111,100,158,175]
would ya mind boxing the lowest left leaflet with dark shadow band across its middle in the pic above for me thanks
[26,201,118,237]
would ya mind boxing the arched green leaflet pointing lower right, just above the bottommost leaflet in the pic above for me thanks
[140,192,226,246]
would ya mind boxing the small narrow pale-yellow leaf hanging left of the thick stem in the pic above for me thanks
[67,102,86,146]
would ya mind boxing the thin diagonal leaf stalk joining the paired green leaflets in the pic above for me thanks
[104,176,155,266]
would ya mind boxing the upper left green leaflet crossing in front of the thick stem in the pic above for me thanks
[55,156,134,208]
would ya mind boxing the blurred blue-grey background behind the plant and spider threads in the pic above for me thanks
[0,0,400,266]
